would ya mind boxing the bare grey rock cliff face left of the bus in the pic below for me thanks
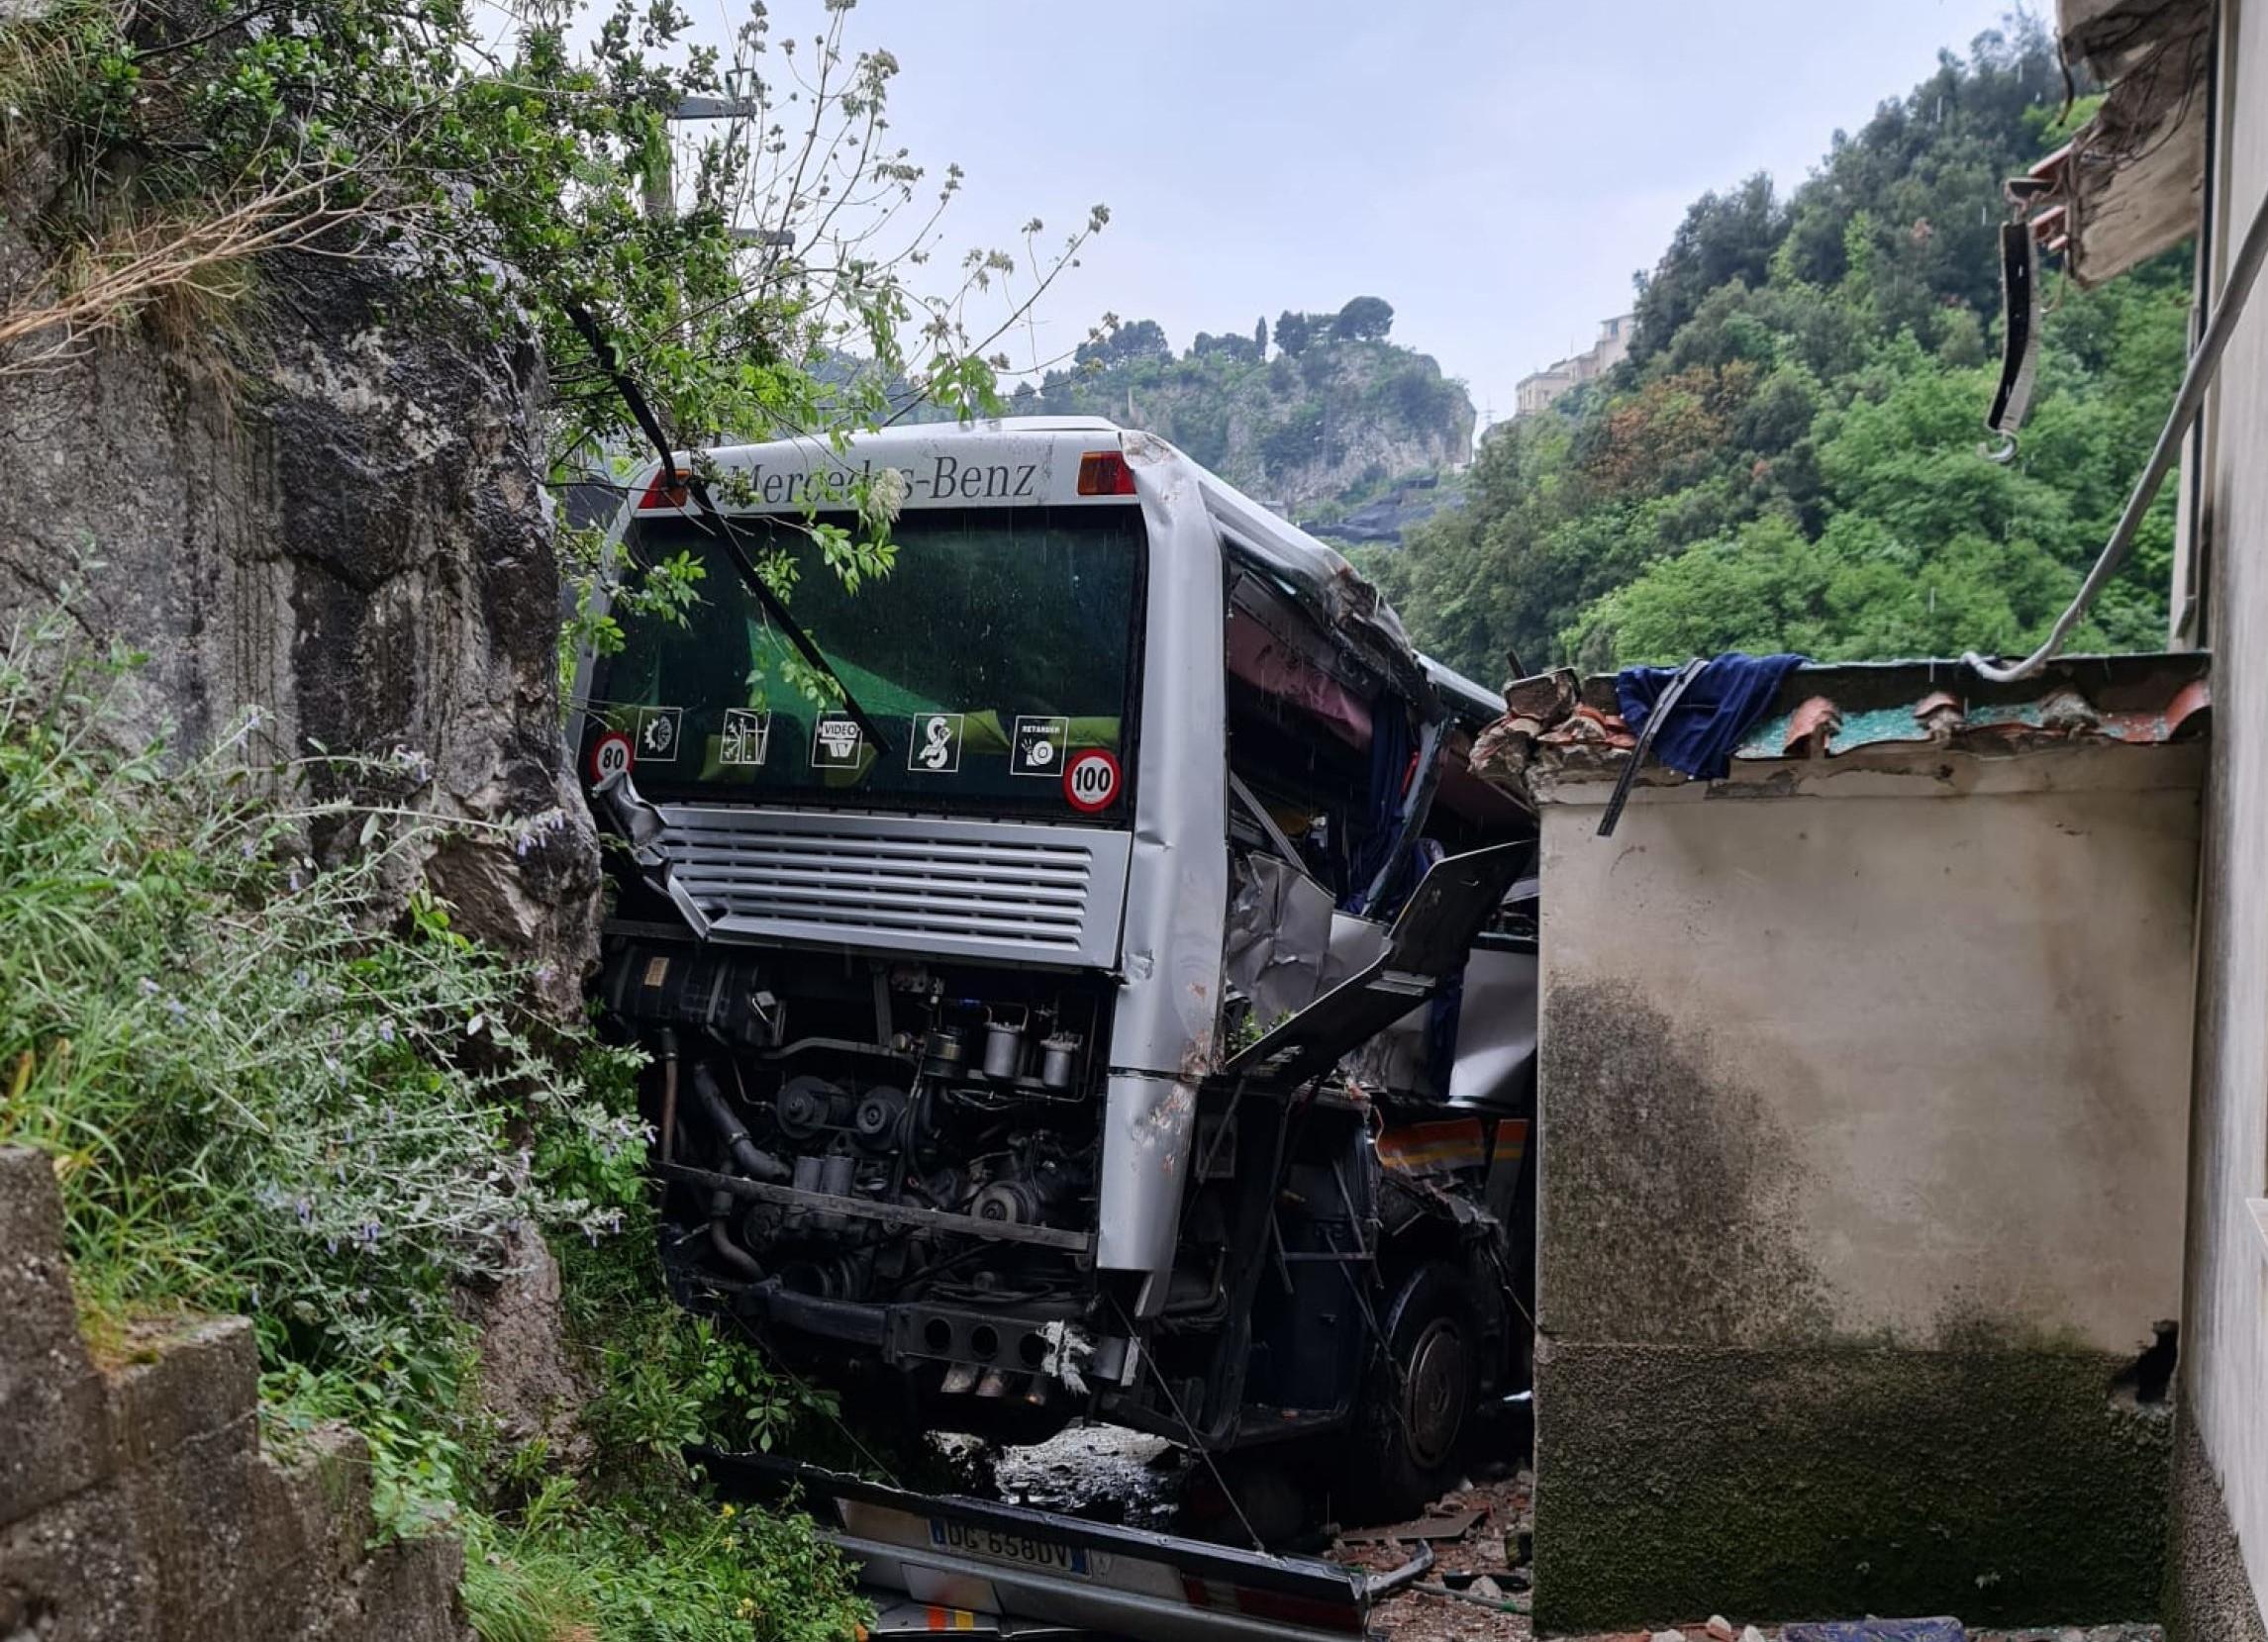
[0,156,597,1010]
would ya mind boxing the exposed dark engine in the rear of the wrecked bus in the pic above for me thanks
[603,941,1109,1398]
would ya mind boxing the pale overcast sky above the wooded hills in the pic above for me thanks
[685,0,2010,418]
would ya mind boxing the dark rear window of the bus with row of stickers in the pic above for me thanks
[583,506,1143,825]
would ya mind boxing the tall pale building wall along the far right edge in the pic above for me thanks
[2175,0,2268,1642]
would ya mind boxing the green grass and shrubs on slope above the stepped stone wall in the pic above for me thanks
[0,615,859,1642]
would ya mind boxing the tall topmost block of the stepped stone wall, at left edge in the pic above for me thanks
[0,1147,111,1524]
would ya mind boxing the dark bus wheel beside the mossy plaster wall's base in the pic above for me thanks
[1363,1266,1479,1517]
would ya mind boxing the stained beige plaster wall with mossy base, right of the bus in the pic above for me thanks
[1535,746,2203,1628]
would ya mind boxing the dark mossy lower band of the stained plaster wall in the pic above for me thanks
[1535,1343,2173,1633]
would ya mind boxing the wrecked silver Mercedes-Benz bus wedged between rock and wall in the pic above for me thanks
[571,420,1535,1512]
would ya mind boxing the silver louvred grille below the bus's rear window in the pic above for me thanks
[662,808,1128,966]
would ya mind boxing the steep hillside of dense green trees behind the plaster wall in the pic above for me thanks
[1365,21,2189,678]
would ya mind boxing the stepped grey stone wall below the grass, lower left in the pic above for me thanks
[0,1150,472,1642]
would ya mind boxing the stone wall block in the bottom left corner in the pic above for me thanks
[0,1484,161,1642]
